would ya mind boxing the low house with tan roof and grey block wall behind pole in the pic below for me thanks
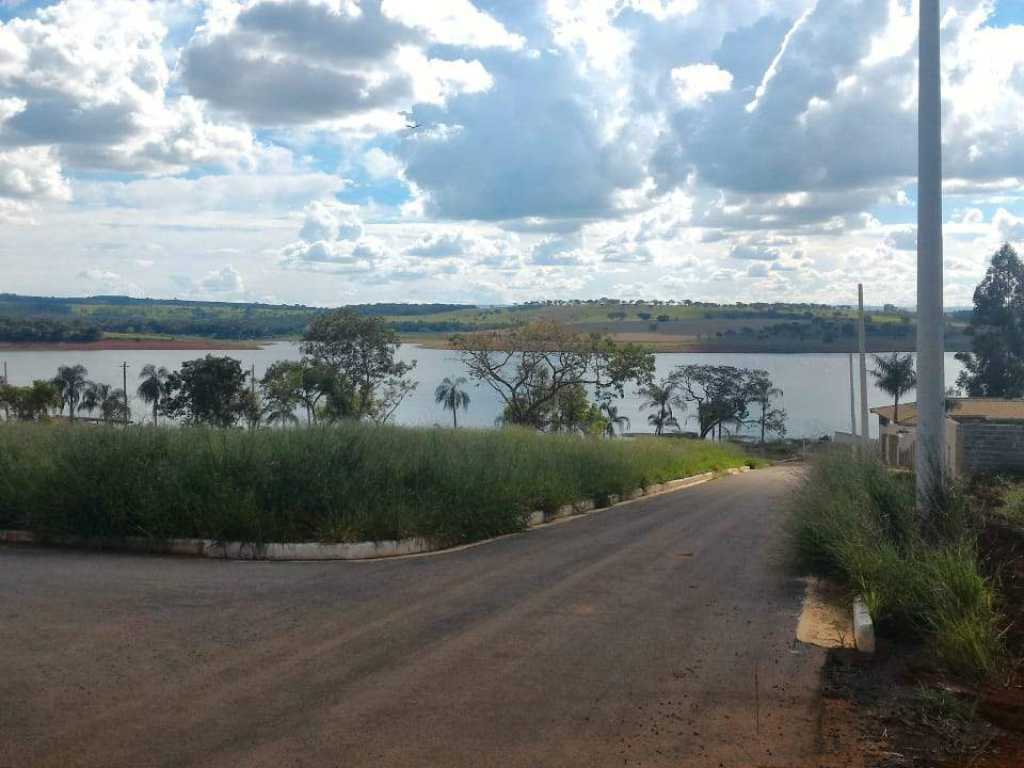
[871,397,1024,477]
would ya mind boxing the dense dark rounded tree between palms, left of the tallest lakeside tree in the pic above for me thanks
[161,354,248,427]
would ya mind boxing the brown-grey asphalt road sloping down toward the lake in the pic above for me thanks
[0,469,823,768]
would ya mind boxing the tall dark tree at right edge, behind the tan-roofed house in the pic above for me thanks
[956,244,1024,398]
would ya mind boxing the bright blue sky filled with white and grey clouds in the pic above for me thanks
[0,0,1024,306]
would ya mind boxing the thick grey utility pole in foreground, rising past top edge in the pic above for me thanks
[916,0,946,501]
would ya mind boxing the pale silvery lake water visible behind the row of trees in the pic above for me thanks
[0,342,962,437]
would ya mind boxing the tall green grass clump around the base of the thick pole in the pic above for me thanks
[791,451,1002,678]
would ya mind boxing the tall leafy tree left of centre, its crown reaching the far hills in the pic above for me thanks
[301,309,416,422]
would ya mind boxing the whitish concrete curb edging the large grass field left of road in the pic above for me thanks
[0,467,751,561]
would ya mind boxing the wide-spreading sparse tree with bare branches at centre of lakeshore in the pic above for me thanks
[452,319,654,430]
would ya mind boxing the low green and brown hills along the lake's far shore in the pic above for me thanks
[0,294,970,352]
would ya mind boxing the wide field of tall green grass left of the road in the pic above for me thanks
[0,424,752,544]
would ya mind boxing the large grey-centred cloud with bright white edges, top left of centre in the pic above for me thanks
[182,0,503,128]
